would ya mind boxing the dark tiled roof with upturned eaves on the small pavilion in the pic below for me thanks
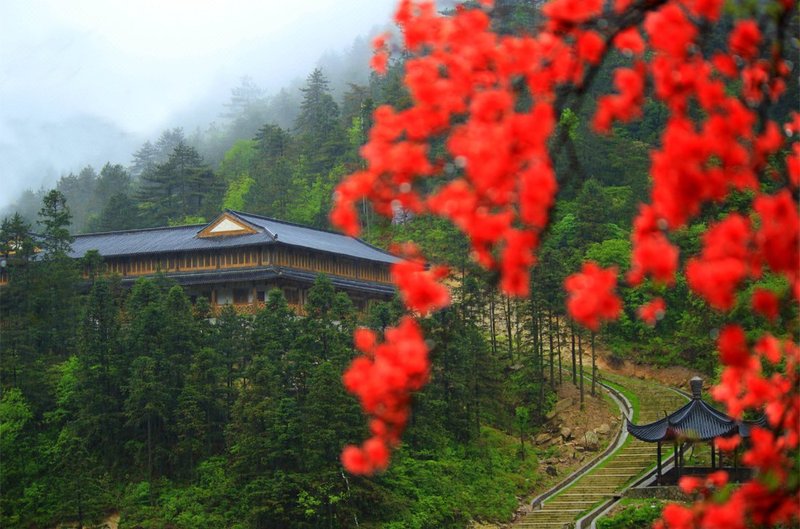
[628,380,764,443]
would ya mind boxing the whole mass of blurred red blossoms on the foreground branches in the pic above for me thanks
[331,4,800,529]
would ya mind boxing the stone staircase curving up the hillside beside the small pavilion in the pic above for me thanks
[513,374,686,529]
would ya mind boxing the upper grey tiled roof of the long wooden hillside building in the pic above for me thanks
[70,211,399,263]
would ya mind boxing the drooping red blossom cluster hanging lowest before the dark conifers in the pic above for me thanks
[342,317,430,475]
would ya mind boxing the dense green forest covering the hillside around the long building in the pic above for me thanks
[0,1,797,529]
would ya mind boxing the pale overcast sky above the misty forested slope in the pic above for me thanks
[0,0,395,208]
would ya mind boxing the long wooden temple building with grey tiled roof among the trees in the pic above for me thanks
[70,210,399,312]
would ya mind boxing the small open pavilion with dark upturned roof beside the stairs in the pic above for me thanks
[627,377,765,484]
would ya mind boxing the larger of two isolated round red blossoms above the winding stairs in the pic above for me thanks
[564,262,622,331]
